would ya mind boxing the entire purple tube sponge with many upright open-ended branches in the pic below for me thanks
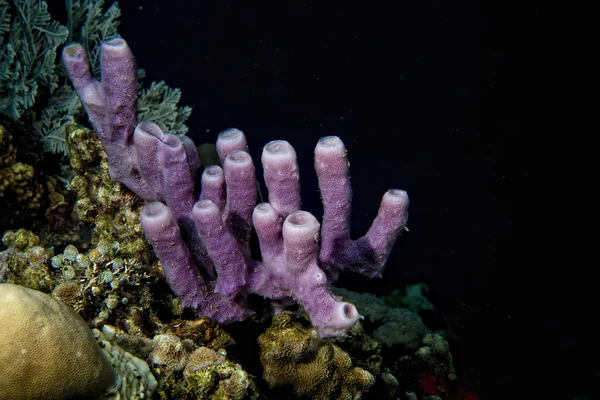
[63,38,408,337]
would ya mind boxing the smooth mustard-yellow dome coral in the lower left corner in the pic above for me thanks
[0,283,116,400]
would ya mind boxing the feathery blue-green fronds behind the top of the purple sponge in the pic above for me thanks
[0,0,192,156]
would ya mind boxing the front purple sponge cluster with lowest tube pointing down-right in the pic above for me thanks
[249,203,360,337]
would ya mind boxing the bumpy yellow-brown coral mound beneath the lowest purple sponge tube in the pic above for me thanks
[258,312,375,400]
